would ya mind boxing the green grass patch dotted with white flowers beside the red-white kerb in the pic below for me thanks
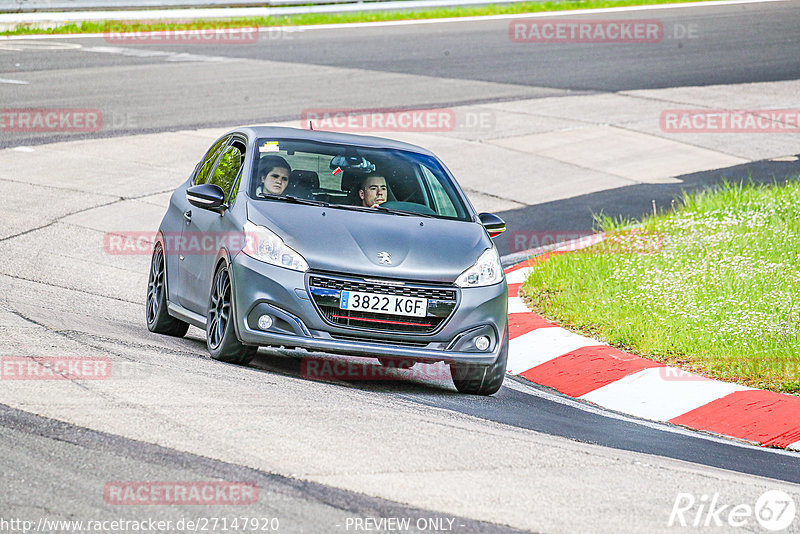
[523,182,800,394]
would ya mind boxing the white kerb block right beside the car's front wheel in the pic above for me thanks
[506,326,605,375]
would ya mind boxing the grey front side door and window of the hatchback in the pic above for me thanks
[180,137,246,315]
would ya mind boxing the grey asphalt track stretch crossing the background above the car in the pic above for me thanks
[0,2,800,142]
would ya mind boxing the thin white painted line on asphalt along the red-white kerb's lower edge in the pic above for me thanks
[503,376,800,458]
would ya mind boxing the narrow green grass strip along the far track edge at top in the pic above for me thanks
[0,0,712,36]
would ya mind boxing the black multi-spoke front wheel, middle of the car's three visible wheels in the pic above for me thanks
[206,265,258,365]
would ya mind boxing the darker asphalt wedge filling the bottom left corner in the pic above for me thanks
[0,405,519,533]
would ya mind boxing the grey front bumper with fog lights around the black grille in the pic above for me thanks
[230,254,508,364]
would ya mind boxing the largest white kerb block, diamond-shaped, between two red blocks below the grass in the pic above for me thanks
[580,367,752,421]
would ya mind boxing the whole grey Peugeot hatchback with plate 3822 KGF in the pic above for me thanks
[146,126,508,395]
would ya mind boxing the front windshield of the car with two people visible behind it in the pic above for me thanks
[250,139,470,221]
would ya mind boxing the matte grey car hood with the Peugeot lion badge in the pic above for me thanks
[248,201,492,282]
